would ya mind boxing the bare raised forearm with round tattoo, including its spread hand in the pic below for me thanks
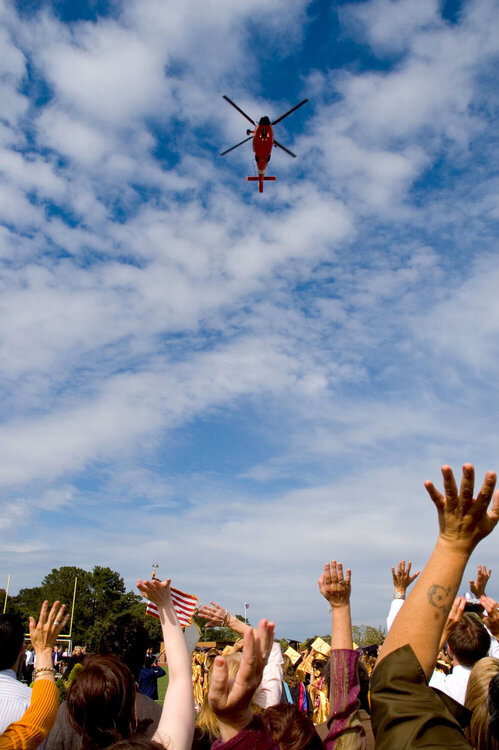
[378,464,499,678]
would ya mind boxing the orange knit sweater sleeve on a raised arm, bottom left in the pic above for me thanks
[0,679,59,750]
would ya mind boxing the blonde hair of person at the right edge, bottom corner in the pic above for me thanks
[464,656,499,750]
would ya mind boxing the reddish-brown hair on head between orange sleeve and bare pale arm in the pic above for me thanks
[67,656,136,750]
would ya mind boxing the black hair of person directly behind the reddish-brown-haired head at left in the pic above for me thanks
[99,614,149,680]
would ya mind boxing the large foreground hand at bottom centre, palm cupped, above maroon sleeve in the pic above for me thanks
[208,620,275,742]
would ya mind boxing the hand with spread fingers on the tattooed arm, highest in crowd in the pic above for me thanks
[425,464,499,555]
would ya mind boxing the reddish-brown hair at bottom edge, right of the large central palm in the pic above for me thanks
[261,703,323,750]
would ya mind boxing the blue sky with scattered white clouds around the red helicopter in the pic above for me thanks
[0,0,499,637]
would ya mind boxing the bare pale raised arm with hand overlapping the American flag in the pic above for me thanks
[137,578,194,750]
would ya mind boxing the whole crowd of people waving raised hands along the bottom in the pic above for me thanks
[0,464,499,750]
